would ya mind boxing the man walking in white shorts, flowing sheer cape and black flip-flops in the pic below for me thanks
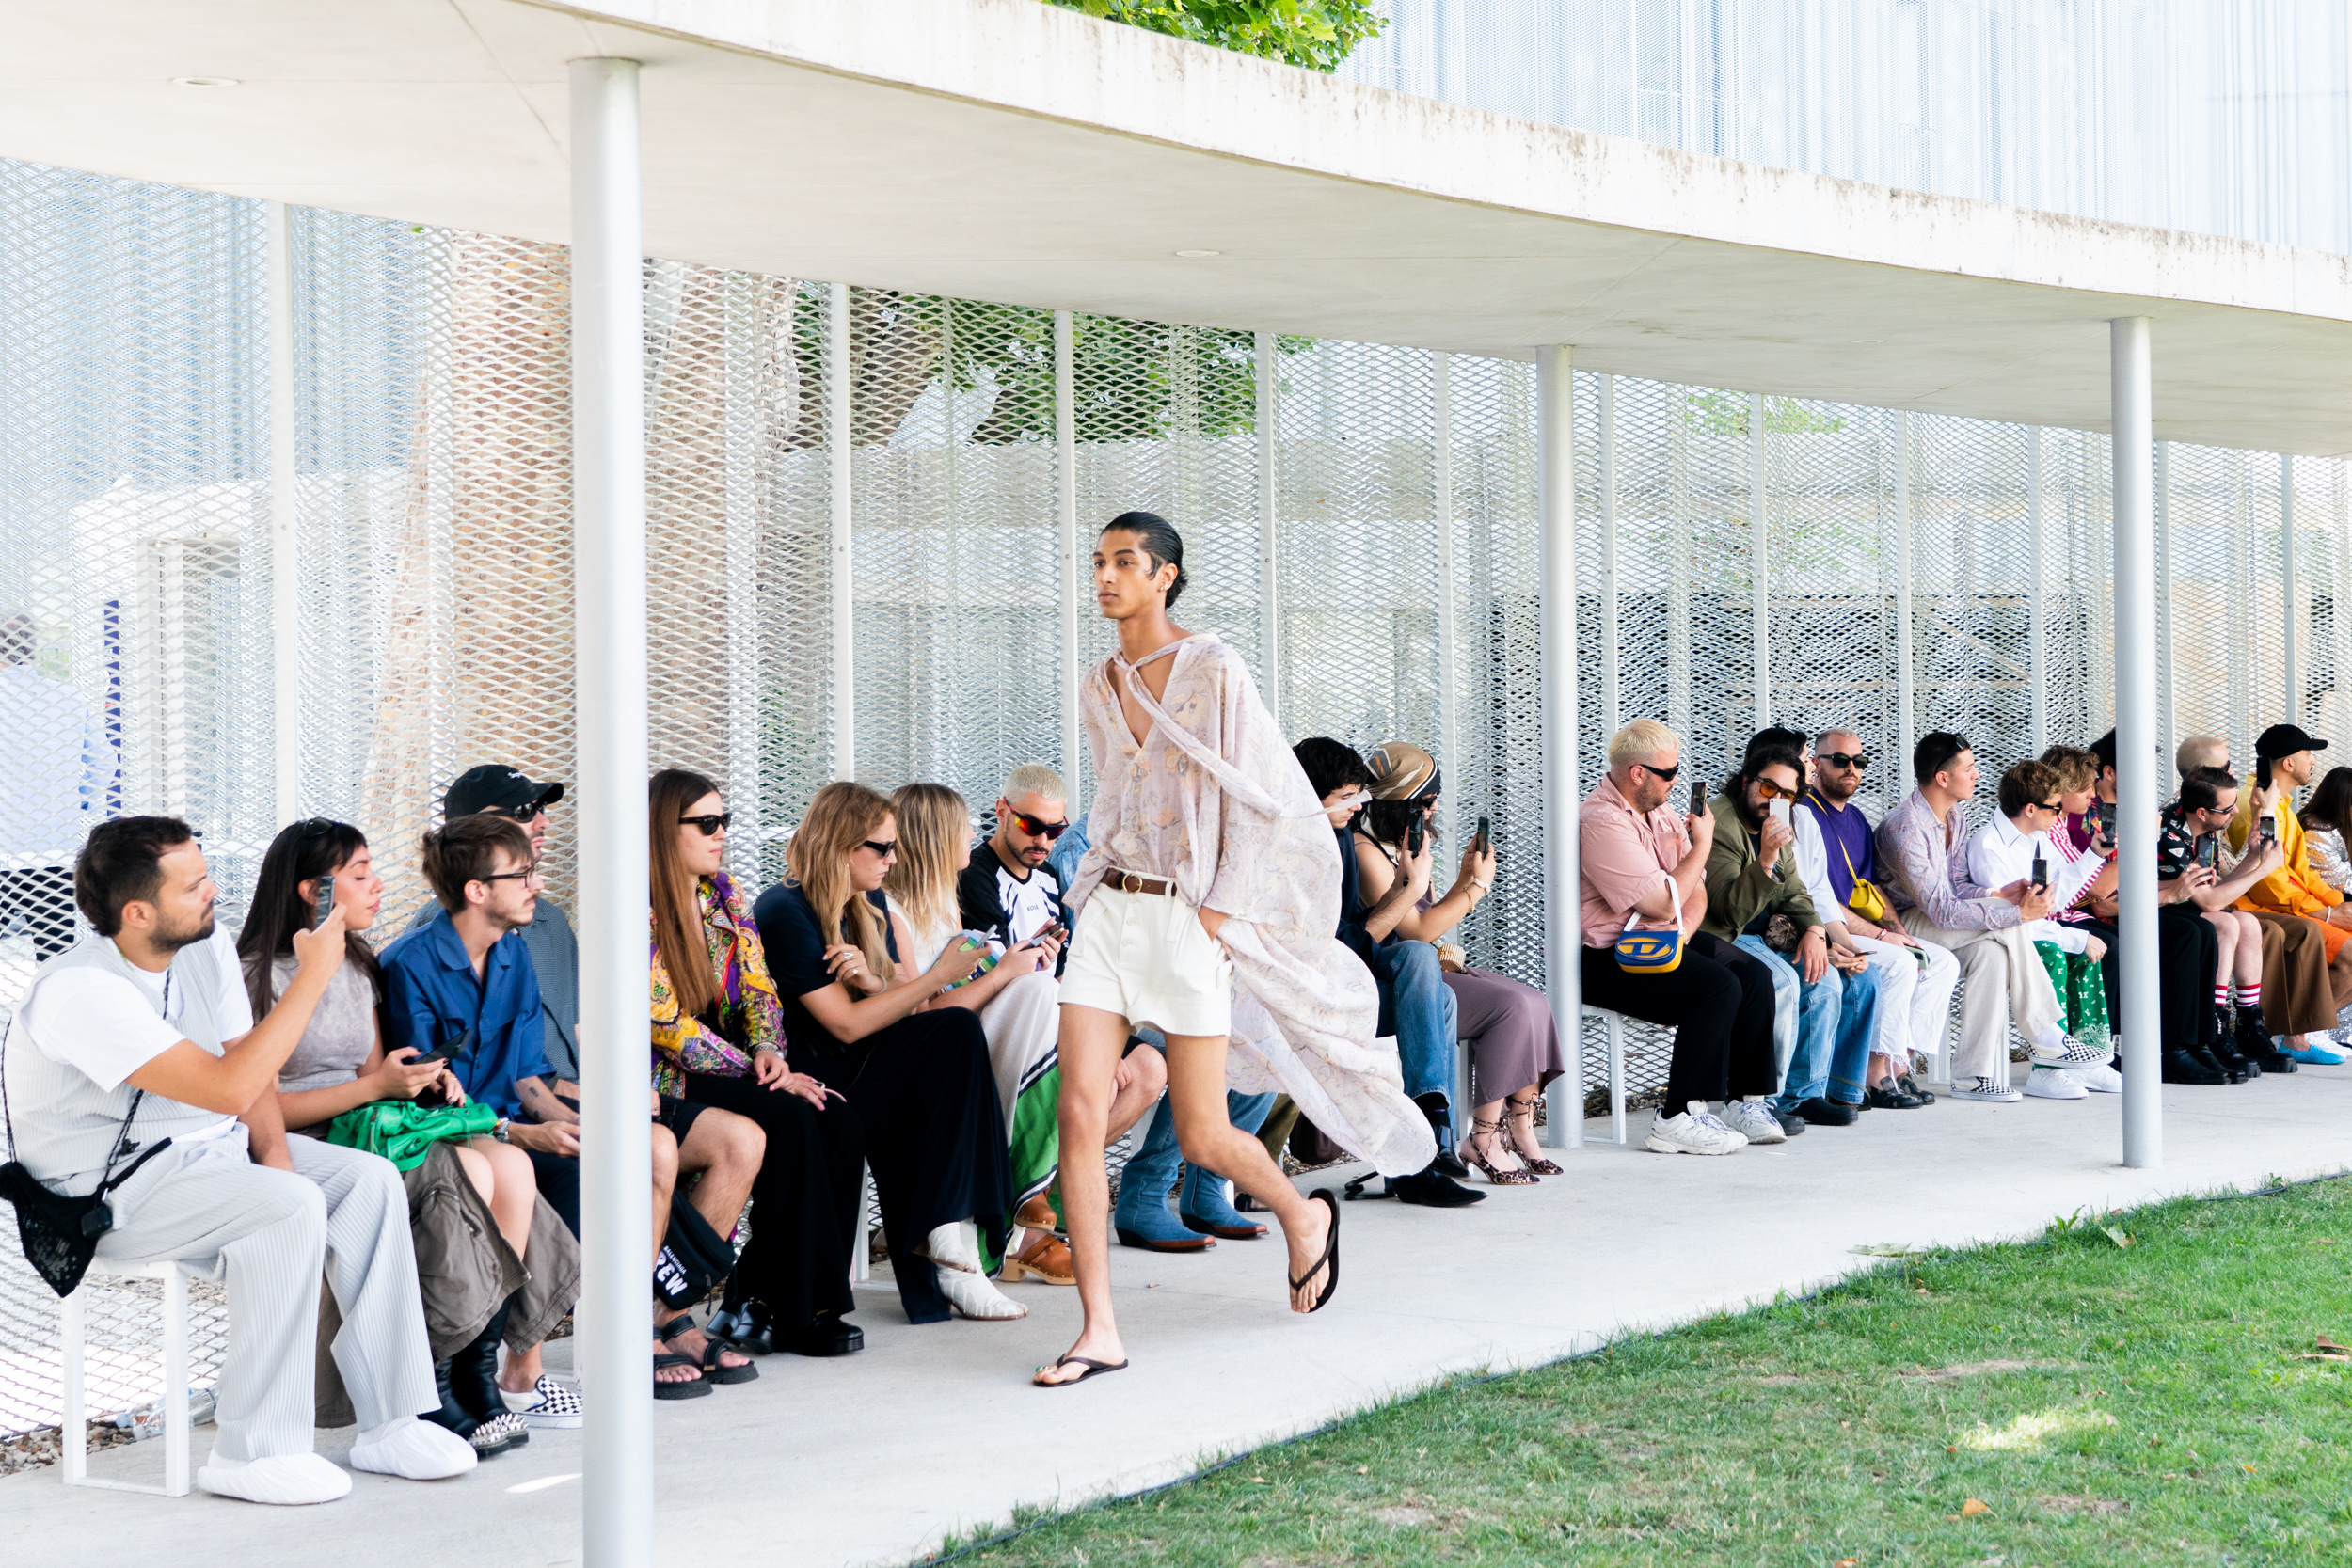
[1035,513,1438,1387]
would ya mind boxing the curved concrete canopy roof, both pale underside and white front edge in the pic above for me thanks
[0,0,2352,453]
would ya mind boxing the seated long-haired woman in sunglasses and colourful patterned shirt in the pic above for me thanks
[649,768,866,1356]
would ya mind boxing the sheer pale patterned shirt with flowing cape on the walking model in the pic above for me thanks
[1066,635,1438,1176]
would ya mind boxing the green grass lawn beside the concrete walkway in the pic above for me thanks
[950,1180,2352,1568]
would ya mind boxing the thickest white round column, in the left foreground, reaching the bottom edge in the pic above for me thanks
[572,58,654,1568]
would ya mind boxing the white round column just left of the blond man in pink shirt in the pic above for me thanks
[1536,343,1585,1149]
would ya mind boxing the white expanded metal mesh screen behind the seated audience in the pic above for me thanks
[0,165,2352,1432]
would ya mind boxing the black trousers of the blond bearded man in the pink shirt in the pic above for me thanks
[1583,933,1781,1117]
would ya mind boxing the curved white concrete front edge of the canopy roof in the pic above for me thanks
[560,0,2352,320]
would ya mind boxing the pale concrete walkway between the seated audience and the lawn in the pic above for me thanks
[0,1068,2352,1568]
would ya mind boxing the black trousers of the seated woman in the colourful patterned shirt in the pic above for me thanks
[682,1072,866,1328]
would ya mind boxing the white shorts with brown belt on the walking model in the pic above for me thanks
[1061,884,1232,1037]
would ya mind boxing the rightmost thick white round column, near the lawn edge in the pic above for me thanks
[2107,315,2164,1168]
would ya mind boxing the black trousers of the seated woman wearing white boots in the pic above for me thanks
[804,1006,1014,1323]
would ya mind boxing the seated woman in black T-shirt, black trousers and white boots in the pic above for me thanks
[753,783,1028,1323]
